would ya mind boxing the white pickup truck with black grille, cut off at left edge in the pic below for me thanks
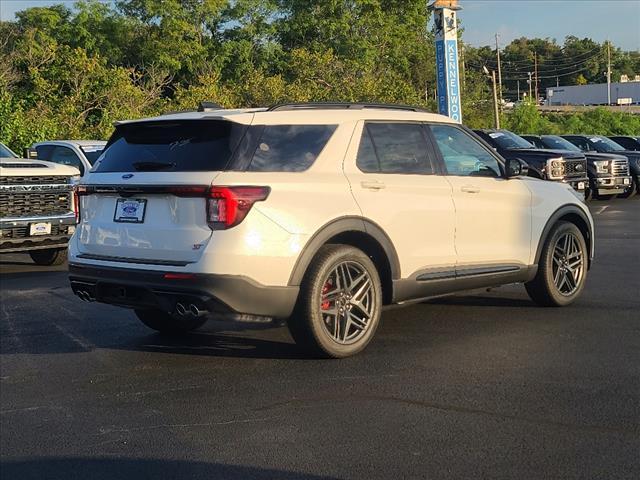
[0,143,80,265]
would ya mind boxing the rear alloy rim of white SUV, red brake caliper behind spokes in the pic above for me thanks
[319,261,376,345]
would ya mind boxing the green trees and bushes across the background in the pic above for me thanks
[0,0,640,151]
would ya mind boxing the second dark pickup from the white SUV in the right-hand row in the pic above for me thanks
[522,135,630,199]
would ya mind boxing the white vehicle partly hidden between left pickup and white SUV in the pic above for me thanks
[30,140,107,175]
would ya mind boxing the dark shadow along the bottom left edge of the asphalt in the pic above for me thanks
[0,457,337,480]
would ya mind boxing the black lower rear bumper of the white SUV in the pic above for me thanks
[69,263,299,318]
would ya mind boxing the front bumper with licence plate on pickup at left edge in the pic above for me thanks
[0,213,76,253]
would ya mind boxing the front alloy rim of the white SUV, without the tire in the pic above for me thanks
[552,232,585,297]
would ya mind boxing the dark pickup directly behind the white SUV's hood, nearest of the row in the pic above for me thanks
[475,130,588,195]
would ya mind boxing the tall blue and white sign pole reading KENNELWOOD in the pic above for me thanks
[429,0,462,123]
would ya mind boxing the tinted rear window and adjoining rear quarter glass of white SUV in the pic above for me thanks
[95,120,337,172]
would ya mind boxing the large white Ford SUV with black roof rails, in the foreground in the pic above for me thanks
[69,104,594,357]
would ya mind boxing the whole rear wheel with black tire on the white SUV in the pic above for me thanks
[287,245,382,358]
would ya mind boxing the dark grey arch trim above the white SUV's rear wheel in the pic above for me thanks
[289,216,400,304]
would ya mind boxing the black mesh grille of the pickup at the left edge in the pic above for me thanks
[0,192,71,217]
